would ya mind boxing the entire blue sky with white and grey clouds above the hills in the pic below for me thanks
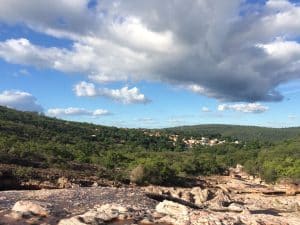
[0,0,300,128]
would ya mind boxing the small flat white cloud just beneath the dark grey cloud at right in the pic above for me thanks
[218,103,269,113]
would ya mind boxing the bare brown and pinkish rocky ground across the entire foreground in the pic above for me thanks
[0,167,300,225]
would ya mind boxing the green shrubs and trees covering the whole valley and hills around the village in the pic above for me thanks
[0,107,300,184]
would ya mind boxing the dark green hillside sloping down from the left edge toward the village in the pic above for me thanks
[0,107,174,167]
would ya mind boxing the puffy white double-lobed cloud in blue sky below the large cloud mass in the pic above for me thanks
[74,81,149,104]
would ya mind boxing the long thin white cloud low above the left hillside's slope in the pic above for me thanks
[47,107,110,117]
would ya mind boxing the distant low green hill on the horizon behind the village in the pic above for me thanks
[165,124,300,142]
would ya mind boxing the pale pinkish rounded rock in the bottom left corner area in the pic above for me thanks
[12,201,50,217]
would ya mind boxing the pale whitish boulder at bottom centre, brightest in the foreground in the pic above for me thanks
[155,200,189,218]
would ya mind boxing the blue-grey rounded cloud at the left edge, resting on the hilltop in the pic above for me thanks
[0,90,43,112]
